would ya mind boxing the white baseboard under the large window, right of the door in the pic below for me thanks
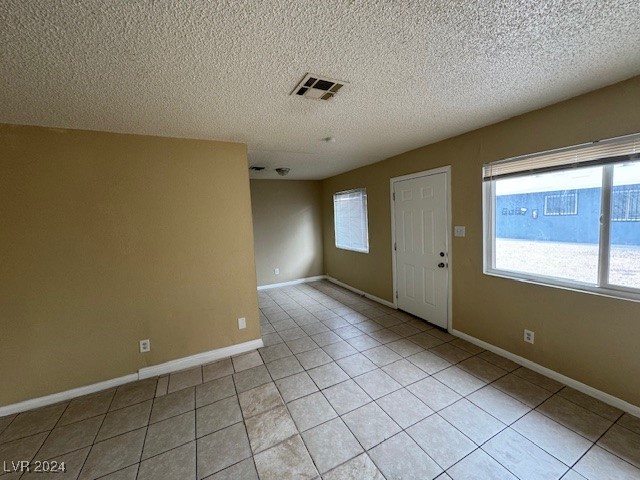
[450,329,640,417]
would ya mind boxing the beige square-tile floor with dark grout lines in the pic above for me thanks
[0,282,640,480]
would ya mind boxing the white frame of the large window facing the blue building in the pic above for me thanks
[482,135,640,302]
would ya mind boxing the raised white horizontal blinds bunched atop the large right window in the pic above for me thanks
[482,134,640,180]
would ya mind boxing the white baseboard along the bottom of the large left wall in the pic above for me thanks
[0,339,264,417]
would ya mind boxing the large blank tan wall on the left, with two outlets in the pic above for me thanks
[0,125,260,405]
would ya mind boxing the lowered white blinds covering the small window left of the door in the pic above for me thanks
[333,188,369,253]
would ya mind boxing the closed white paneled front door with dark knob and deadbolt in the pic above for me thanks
[392,172,449,328]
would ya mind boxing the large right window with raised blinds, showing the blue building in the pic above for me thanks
[483,134,640,300]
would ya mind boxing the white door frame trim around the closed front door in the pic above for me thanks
[389,165,453,331]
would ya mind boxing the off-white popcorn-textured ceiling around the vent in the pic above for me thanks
[0,0,640,179]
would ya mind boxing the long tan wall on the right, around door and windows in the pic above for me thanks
[323,77,640,405]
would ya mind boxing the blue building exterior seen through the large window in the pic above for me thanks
[495,184,640,245]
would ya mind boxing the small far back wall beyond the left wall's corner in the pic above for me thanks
[251,180,323,285]
